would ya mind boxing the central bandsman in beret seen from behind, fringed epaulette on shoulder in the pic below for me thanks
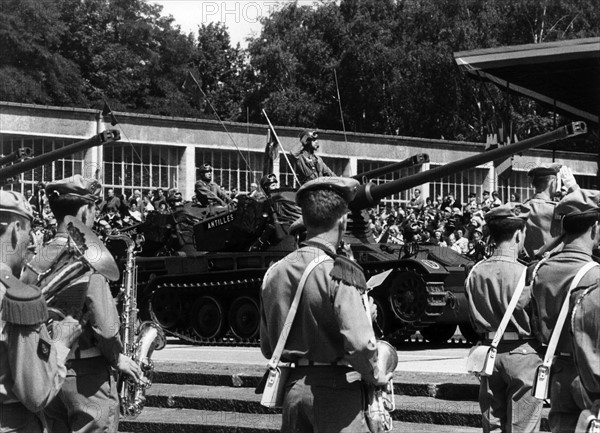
[260,178,391,433]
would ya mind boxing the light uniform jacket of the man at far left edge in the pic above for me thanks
[0,263,69,412]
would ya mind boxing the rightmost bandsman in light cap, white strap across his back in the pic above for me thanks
[532,189,600,433]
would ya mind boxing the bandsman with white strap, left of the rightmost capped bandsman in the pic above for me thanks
[466,203,542,432]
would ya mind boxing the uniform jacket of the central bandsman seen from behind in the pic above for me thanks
[260,238,377,378]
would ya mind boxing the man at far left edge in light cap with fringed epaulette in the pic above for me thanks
[0,191,81,433]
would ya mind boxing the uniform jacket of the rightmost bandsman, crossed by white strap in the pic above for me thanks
[532,245,600,353]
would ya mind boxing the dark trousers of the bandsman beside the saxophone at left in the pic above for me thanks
[45,356,119,433]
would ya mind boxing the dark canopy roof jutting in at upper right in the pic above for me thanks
[454,38,600,124]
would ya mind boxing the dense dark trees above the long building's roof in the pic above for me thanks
[0,0,600,141]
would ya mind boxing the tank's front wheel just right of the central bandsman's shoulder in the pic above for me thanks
[390,271,427,323]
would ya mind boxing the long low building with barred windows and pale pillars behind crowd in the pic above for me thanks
[0,102,598,205]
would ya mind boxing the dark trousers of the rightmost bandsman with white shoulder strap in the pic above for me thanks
[548,356,592,433]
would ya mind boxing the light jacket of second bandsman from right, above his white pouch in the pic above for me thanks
[466,249,532,337]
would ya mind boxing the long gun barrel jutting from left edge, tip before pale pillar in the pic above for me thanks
[0,129,121,183]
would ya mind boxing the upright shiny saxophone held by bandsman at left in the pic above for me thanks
[107,234,167,419]
